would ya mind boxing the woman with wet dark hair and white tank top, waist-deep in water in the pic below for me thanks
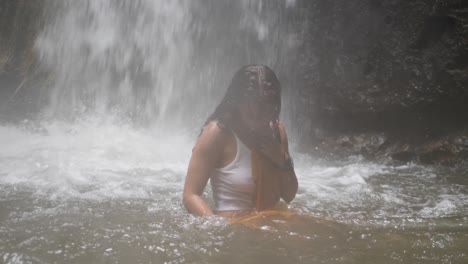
[183,65,298,218]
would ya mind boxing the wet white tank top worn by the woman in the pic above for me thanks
[210,133,255,212]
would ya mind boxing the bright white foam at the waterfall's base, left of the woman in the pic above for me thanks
[0,118,193,198]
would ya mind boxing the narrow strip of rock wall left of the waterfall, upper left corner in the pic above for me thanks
[0,0,43,119]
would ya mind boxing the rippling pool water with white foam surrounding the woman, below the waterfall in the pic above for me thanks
[0,118,468,263]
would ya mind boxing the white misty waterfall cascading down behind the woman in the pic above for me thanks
[36,0,297,132]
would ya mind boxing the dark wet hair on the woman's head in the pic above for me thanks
[204,65,281,128]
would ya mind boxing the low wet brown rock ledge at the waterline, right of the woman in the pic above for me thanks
[308,130,468,165]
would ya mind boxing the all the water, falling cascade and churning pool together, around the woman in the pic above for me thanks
[0,1,468,264]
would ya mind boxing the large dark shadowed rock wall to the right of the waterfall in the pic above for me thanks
[292,0,468,163]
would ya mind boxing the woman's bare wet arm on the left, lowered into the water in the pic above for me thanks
[183,122,225,216]
